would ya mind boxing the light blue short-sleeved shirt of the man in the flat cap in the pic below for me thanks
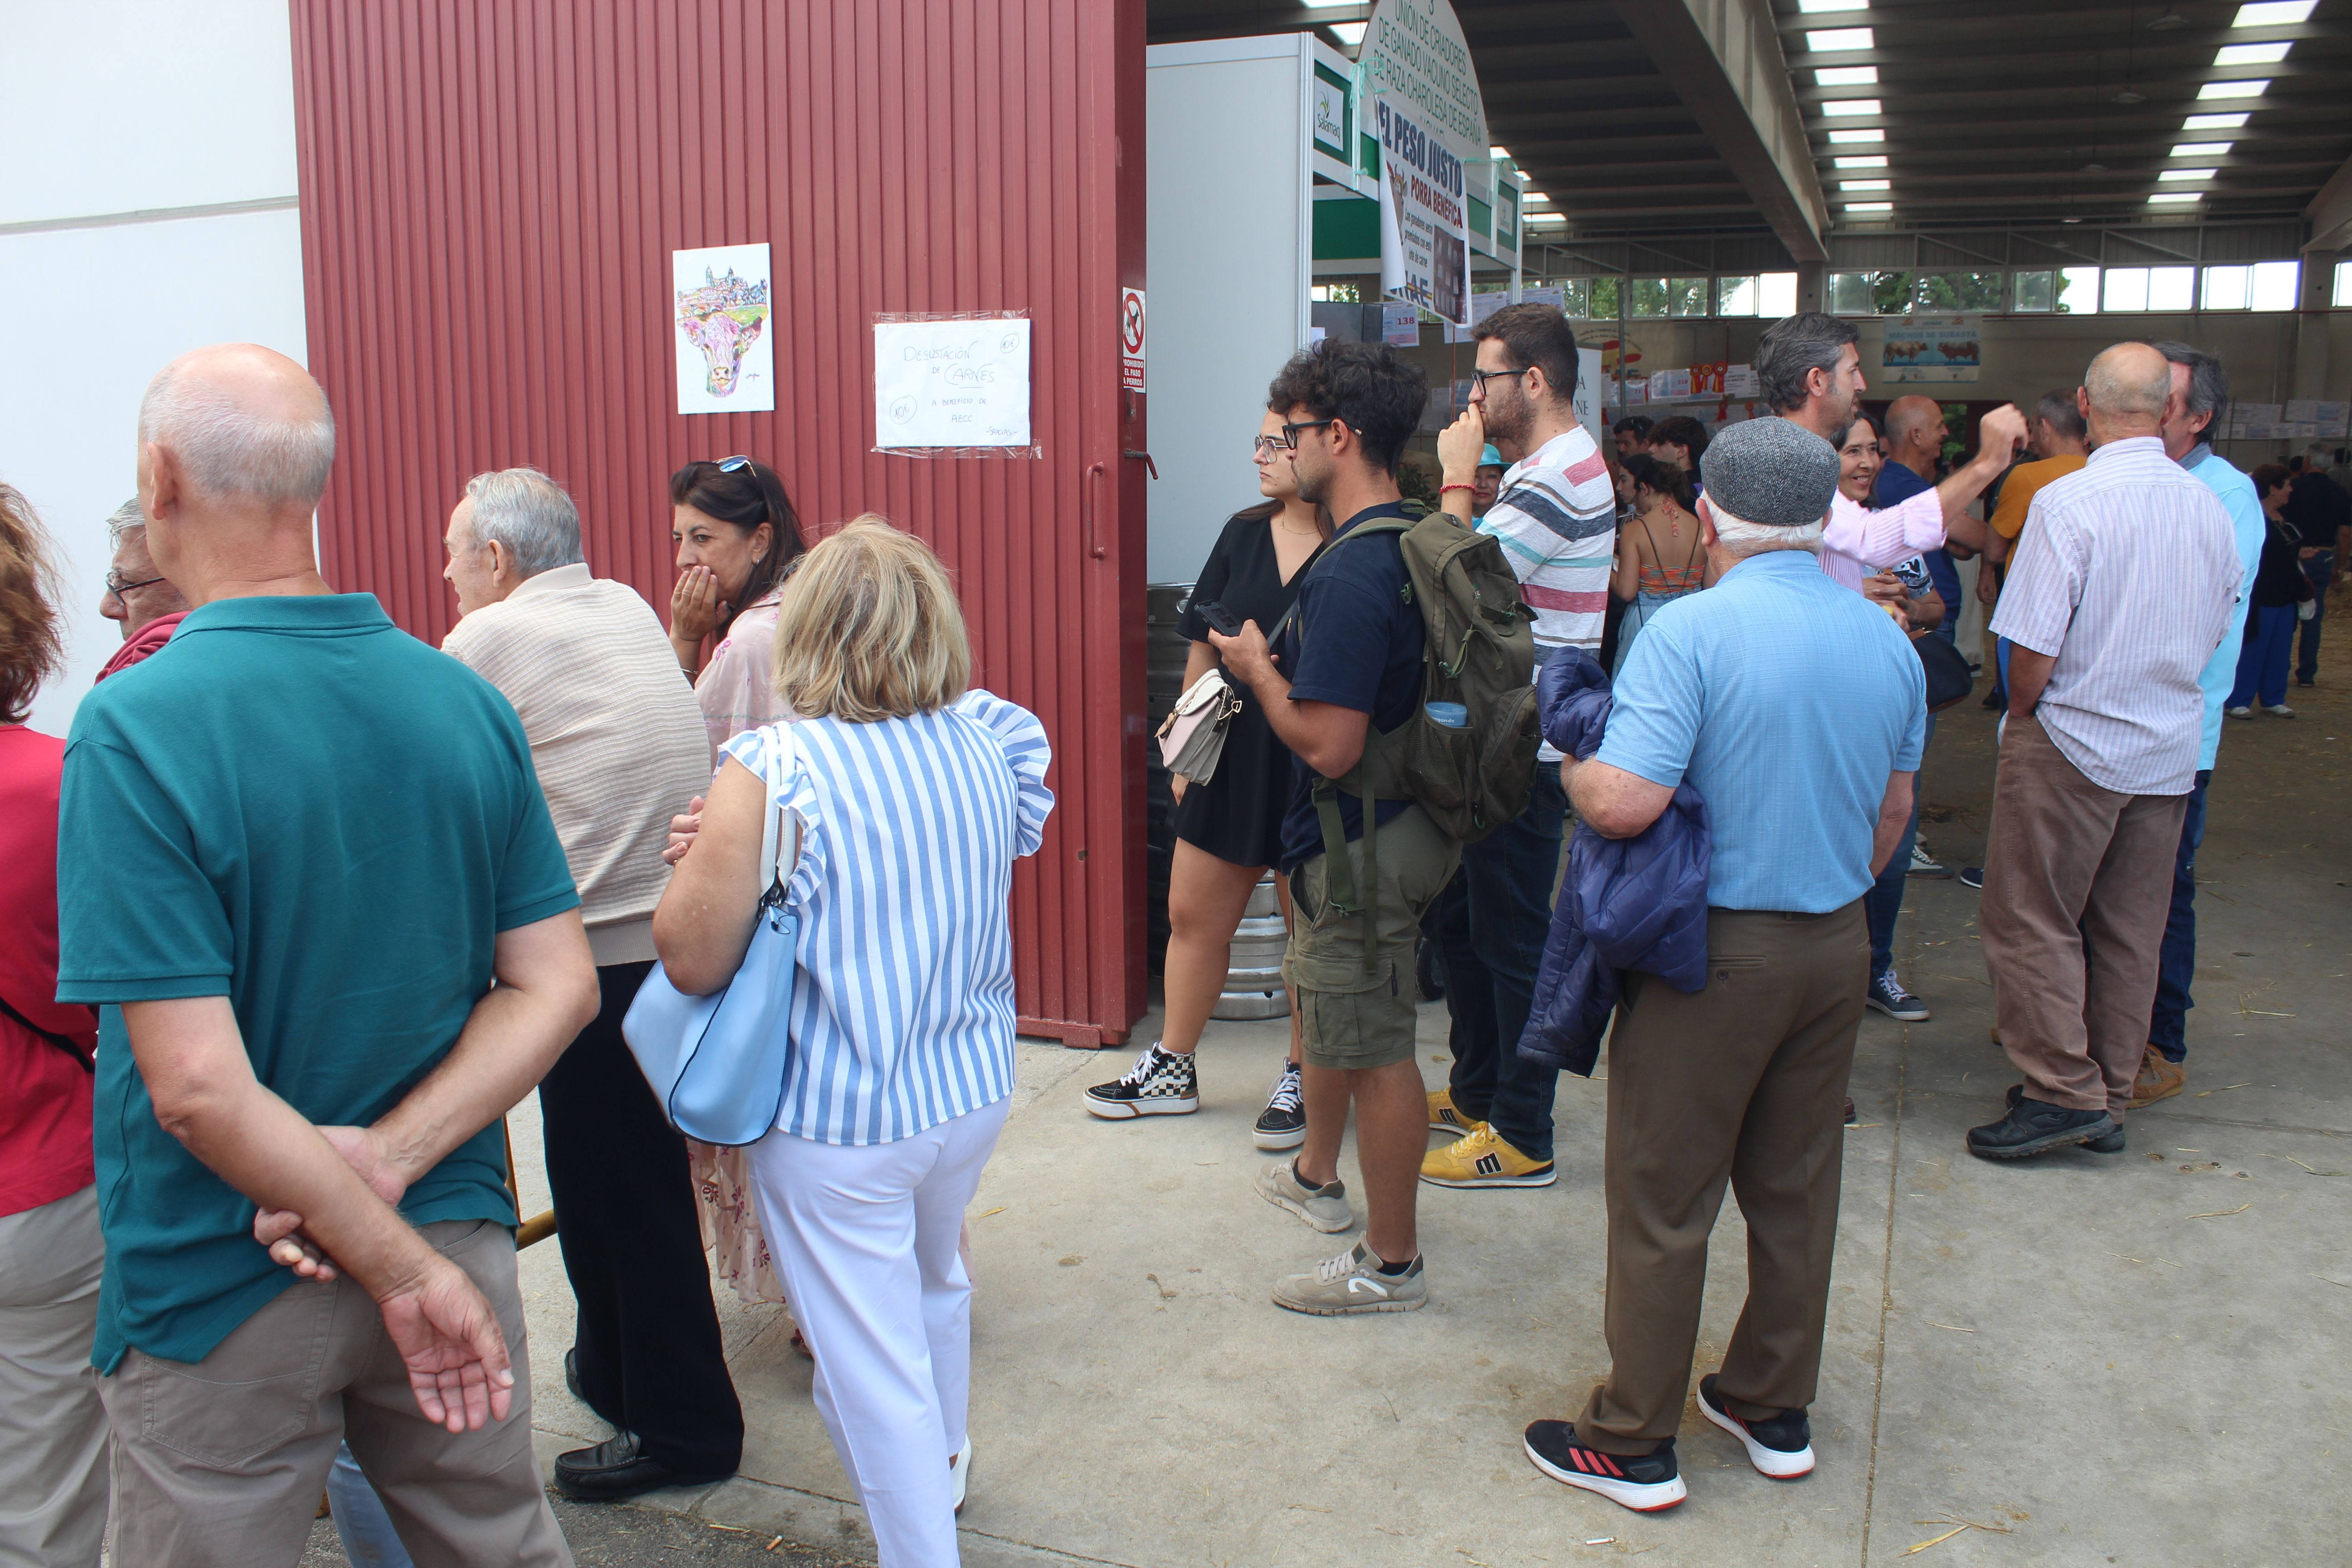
[1599,550,1926,915]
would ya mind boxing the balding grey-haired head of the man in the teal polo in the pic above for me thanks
[139,343,334,515]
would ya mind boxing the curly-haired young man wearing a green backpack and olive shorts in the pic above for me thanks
[1209,343,1536,1317]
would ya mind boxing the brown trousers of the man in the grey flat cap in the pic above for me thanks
[1576,900,1870,1455]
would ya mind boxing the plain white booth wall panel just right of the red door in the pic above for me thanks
[1143,33,1310,583]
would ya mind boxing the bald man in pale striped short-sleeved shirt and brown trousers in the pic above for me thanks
[1969,343,2244,1159]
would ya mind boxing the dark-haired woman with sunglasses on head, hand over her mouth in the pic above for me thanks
[670,456,807,1316]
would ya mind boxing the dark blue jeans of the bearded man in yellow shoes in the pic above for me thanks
[1430,762,1569,1159]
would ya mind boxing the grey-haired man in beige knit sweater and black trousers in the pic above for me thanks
[442,468,743,1498]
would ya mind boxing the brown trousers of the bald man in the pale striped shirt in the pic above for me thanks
[1978,715,2190,1122]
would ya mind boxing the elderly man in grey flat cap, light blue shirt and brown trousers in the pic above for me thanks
[1526,418,1926,1509]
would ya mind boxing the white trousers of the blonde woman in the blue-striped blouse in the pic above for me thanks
[750,1098,1011,1568]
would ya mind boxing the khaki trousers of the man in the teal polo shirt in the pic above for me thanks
[99,1220,572,1568]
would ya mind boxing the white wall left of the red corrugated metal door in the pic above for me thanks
[0,0,306,734]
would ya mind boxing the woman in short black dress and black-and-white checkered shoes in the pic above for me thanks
[1087,414,1331,1150]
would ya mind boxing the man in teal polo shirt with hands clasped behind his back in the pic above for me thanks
[56,343,598,1568]
